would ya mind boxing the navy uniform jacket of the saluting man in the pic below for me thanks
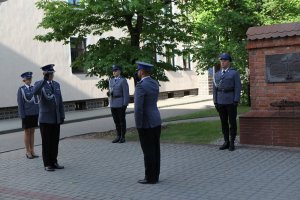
[33,80,65,124]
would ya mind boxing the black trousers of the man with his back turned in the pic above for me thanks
[138,126,161,182]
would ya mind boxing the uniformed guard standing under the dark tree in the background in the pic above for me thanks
[107,65,129,143]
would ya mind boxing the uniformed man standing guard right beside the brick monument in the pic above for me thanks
[213,53,242,151]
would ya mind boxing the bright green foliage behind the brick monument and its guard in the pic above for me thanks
[191,0,300,104]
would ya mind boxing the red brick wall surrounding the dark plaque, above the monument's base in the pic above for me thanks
[247,36,300,111]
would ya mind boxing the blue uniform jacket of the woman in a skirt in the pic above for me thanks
[17,85,39,119]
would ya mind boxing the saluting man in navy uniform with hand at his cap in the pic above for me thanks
[33,64,65,171]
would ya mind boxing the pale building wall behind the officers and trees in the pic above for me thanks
[0,0,207,107]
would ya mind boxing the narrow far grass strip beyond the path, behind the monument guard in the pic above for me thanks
[163,106,250,122]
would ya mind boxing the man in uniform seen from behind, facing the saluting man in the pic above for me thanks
[134,62,161,184]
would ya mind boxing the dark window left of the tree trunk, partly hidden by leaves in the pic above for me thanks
[70,38,86,74]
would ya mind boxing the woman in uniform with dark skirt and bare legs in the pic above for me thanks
[17,72,39,159]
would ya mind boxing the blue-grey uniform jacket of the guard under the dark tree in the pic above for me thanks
[109,77,129,108]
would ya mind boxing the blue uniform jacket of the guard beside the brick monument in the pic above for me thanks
[213,68,242,104]
